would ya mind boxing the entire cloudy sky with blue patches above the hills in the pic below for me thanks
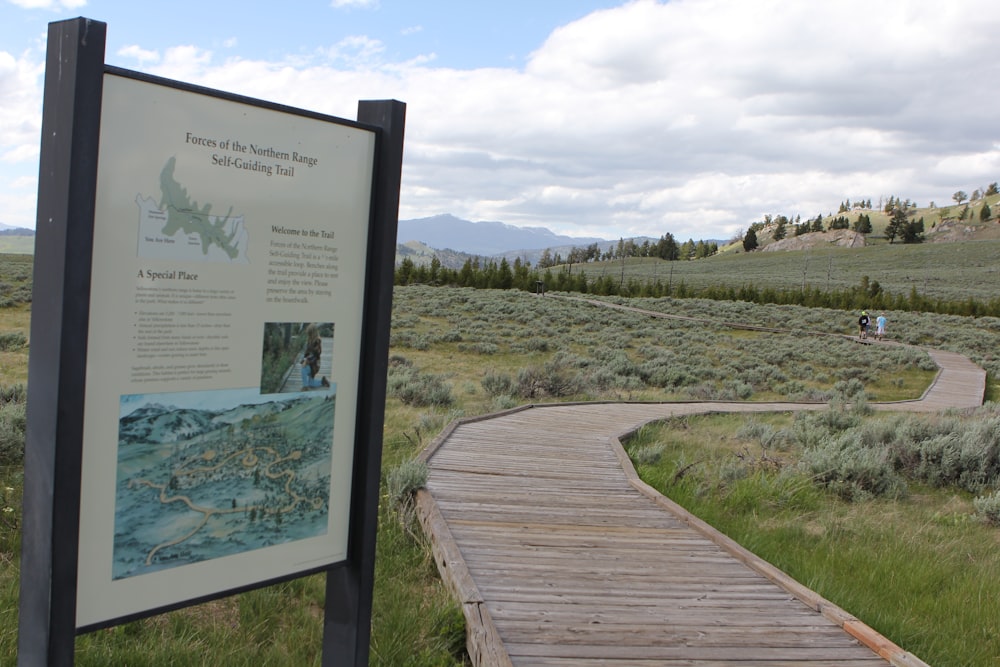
[0,0,1000,240]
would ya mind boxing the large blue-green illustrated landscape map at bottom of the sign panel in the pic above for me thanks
[112,386,337,579]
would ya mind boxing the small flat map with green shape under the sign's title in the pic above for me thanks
[135,157,248,263]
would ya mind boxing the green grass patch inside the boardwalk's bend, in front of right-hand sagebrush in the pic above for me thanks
[626,414,1000,667]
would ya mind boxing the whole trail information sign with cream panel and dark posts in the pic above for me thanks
[20,19,402,664]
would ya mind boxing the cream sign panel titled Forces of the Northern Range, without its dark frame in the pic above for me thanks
[76,73,375,629]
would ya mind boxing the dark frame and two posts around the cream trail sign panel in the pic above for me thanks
[18,18,405,667]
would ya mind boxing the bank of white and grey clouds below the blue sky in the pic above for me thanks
[0,0,1000,239]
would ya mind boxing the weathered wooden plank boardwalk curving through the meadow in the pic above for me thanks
[417,306,985,667]
